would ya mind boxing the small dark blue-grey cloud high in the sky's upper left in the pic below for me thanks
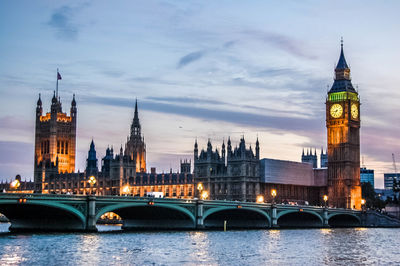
[47,6,79,40]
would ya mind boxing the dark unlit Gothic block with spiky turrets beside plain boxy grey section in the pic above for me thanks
[194,137,261,201]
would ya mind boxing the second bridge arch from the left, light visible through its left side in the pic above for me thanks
[95,202,196,229]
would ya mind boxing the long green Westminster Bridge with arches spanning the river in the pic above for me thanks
[0,193,400,232]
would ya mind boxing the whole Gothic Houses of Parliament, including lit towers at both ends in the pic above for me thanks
[0,43,361,209]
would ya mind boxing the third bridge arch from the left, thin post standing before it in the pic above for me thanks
[203,206,271,228]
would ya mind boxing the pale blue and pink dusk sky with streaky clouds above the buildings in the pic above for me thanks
[0,0,400,188]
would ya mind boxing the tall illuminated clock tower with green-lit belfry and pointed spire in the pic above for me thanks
[326,41,361,209]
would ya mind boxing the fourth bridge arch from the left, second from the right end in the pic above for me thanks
[276,209,324,227]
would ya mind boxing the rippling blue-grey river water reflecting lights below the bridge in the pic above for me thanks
[0,224,400,265]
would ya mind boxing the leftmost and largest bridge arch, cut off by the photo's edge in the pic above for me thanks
[0,198,86,231]
